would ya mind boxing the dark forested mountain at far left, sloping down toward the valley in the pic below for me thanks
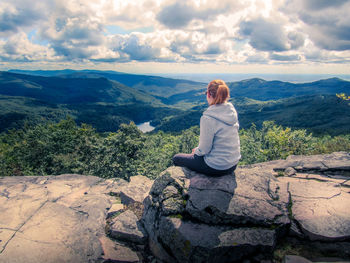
[0,72,185,132]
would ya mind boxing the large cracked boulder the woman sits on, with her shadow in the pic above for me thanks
[143,167,289,262]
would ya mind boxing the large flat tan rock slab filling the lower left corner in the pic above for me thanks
[0,174,126,263]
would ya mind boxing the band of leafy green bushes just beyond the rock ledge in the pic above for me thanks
[0,118,350,179]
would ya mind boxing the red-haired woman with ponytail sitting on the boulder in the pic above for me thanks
[173,80,241,176]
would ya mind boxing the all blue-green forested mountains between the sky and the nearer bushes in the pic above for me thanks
[0,70,350,134]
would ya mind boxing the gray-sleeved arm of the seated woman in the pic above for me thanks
[194,116,215,156]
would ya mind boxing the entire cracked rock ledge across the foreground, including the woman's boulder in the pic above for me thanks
[0,152,350,263]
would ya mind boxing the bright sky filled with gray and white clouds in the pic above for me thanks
[0,0,350,74]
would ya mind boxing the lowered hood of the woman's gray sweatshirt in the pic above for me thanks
[203,102,238,125]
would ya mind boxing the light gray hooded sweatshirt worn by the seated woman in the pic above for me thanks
[194,102,241,170]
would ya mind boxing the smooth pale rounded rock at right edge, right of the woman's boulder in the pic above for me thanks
[279,174,350,241]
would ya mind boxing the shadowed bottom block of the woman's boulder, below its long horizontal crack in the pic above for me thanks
[158,217,275,262]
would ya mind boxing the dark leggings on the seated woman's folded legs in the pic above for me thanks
[173,153,237,176]
